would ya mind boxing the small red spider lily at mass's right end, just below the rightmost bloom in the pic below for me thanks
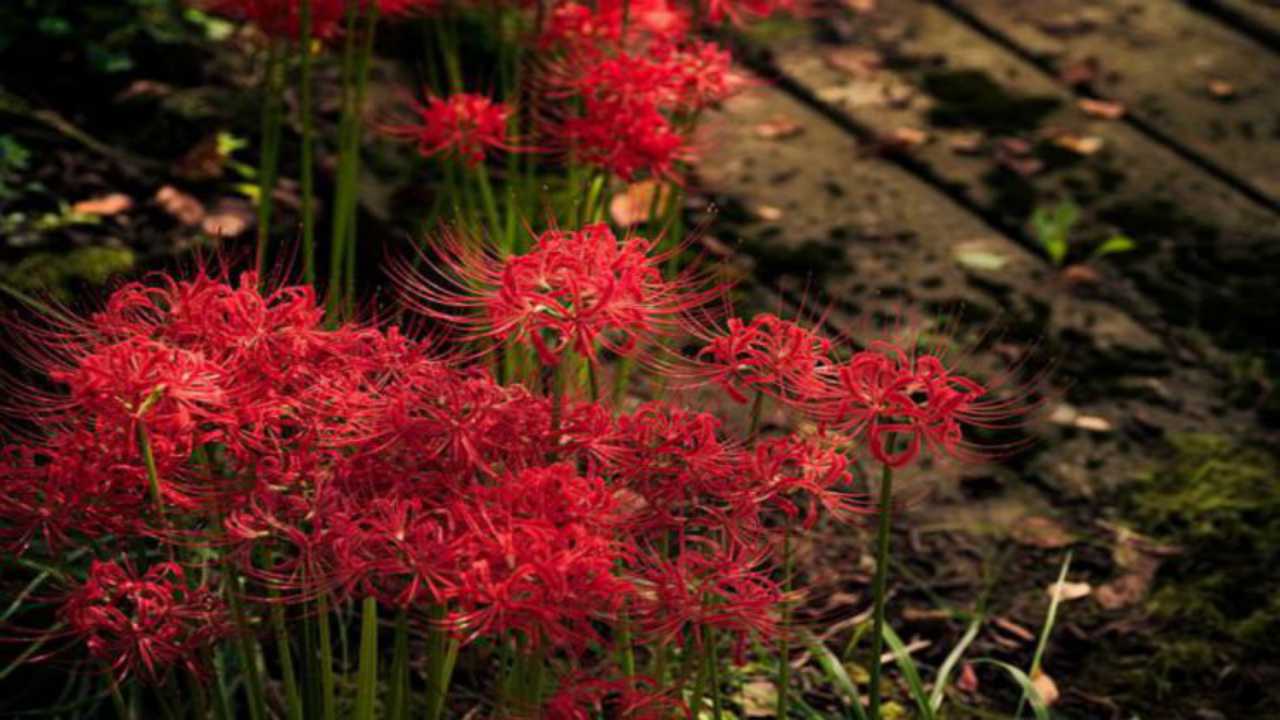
[745,436,870,529]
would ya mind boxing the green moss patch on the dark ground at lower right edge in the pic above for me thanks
[1121,434,1280,712]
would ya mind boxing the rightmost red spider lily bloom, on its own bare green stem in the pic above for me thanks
[820,341,1036,468]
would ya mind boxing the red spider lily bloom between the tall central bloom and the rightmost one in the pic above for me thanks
[673,313,832,402]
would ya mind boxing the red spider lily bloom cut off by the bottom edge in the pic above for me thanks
[539,673,692,720]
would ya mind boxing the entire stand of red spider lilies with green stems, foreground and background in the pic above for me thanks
[0,0,1049,720]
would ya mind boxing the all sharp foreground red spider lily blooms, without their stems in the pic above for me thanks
[0,233,1034,717]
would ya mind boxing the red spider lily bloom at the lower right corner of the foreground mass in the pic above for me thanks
[634,537,782,653]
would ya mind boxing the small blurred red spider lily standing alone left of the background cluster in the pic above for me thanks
[385,92,517,167]
